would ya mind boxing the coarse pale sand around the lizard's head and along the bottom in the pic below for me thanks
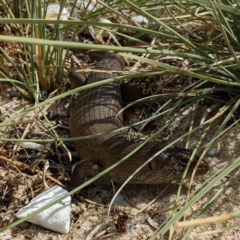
[0,81,240,240]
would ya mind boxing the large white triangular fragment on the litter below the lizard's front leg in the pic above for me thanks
[16,185,71,234]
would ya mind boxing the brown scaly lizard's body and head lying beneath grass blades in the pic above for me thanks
[69,53,208,188]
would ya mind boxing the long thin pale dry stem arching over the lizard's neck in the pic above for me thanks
[108,106,230,215]
